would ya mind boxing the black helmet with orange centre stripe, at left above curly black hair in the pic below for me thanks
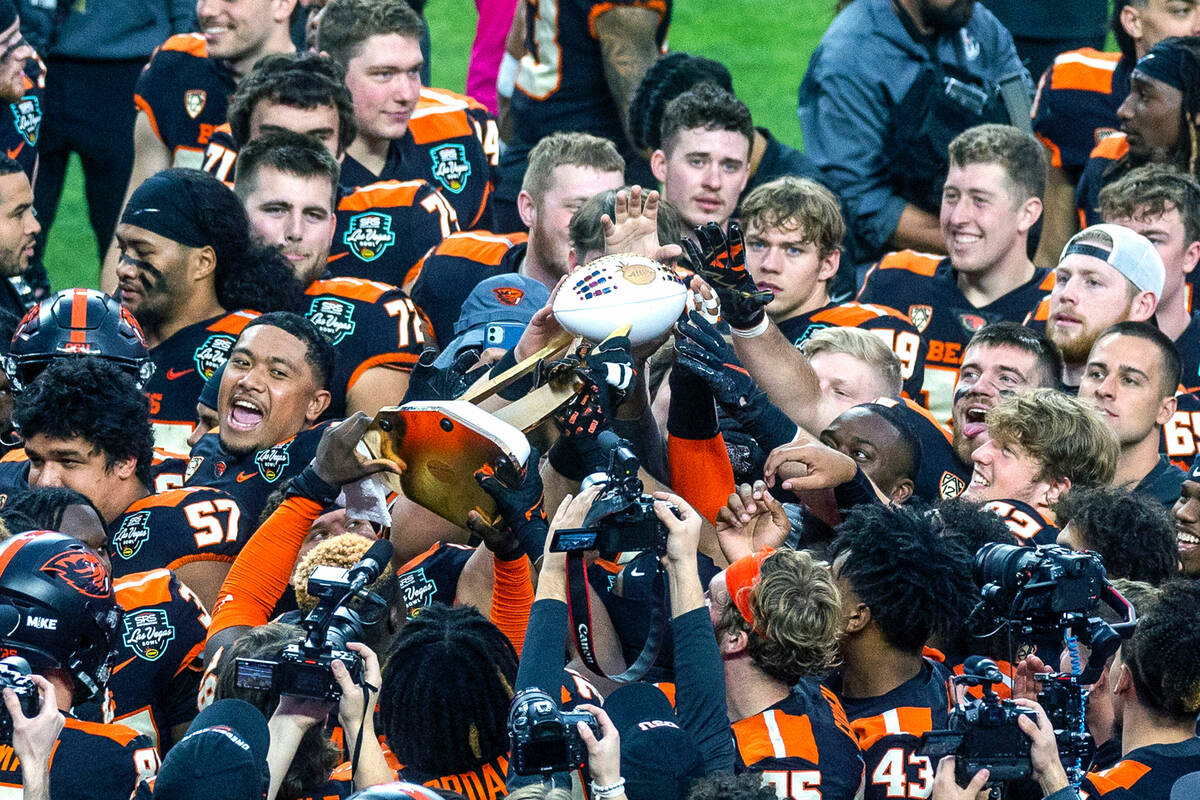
[5,289,154,391]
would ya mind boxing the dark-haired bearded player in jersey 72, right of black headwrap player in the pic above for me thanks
[235,132,433,419]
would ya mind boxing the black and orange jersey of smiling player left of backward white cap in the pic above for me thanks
[858,249,1054,422]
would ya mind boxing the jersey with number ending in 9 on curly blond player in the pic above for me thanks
[779,302,929,399]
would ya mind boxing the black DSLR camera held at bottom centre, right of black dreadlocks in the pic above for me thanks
[509,688,600,775]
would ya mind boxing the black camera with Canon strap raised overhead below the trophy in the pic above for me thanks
[550,439,679,558]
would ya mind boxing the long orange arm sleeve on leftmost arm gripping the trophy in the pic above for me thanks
[209,497,320,636]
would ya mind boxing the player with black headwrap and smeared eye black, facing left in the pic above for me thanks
[115,169,301,456]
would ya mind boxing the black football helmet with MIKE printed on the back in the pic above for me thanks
[0,530,124,705]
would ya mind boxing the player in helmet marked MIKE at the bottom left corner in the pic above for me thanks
[0,531,158,800]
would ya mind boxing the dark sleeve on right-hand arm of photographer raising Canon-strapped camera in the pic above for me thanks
[671,608,734,775]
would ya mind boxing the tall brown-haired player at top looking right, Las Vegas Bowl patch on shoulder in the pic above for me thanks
[317,0,499,229]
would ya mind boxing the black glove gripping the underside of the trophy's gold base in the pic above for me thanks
[472,447,550,561]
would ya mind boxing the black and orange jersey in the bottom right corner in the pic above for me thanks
[1079,736,1200,800]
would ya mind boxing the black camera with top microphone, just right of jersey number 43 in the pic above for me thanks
[918,656,1037,786]
